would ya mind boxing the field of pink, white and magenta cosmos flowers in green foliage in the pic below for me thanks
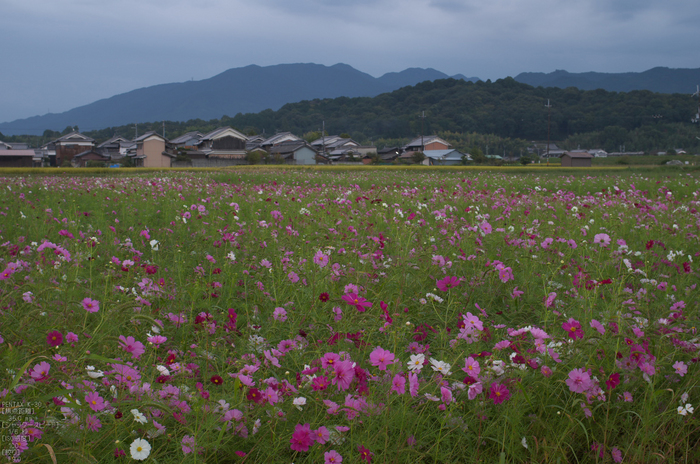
[0,169,700,463]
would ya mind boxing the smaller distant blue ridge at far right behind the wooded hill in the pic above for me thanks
[515,67,700,93]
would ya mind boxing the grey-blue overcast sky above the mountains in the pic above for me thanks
[0,0,700,122]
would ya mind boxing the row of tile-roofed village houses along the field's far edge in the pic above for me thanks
[0,127,471,168]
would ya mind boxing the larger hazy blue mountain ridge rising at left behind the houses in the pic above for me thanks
[0,63,479,135]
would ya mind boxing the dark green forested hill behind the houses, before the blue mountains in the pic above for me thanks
[5,78,698,151]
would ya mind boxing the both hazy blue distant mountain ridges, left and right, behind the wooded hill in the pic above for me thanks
[0,63,700,135]
